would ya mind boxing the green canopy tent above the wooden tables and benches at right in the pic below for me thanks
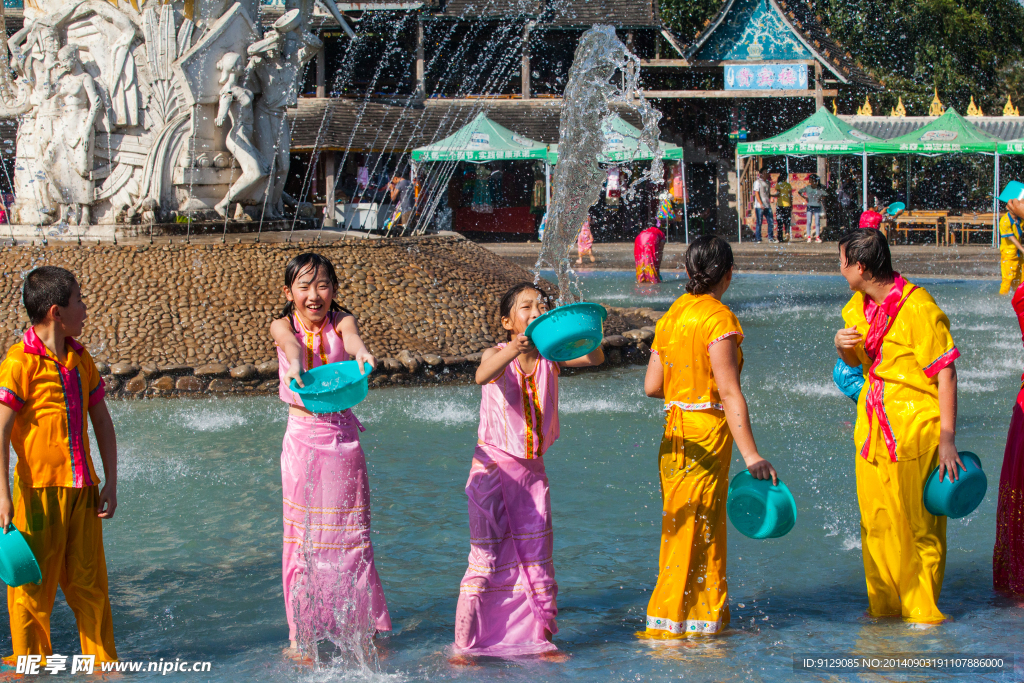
[864,112,999,246]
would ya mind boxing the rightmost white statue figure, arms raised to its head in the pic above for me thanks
[247,9,324,218]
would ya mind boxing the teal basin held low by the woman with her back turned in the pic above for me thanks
[725,470,797,539]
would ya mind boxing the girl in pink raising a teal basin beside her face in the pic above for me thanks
[452,283,604,664]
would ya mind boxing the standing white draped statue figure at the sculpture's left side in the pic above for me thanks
[42,45,103,225]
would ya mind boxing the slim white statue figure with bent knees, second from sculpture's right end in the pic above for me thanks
[214,52,267,217]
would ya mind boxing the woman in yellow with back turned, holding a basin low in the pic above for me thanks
[637,236,777,638]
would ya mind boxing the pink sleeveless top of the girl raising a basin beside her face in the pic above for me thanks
[477,342,560,460]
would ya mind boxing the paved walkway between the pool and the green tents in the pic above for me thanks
[481,242,999,279]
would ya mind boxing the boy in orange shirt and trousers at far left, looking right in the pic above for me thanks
[0,266,118,664]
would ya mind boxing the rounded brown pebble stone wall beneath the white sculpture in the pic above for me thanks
[0,237,657,395]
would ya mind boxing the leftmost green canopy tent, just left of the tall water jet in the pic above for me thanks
[412,112,550,237]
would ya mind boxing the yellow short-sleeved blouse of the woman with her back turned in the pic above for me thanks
[651,294,743,411]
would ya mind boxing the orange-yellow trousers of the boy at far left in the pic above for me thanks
[7,475,118,661]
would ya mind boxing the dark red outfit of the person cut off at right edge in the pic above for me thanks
[992,287,1024,595]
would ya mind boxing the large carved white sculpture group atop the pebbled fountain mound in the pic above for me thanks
[0,0,323,234]
